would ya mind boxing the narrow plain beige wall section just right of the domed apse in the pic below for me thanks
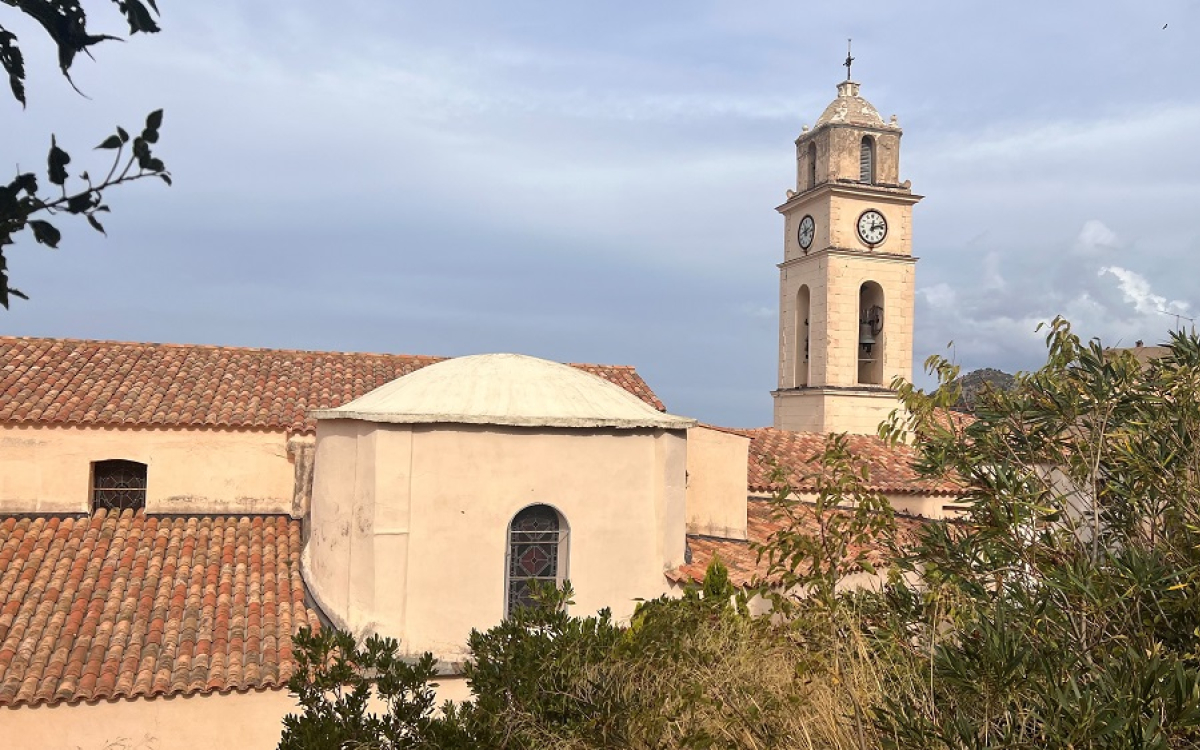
[686,427,750,539]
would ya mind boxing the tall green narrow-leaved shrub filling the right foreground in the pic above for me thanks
[872,319,1200,750]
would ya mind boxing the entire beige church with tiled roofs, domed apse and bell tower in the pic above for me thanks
[0,73,955,750]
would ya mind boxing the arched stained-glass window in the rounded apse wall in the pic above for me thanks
[504,505,566,616]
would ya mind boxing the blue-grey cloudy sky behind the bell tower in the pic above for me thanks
[0,0,1200,426]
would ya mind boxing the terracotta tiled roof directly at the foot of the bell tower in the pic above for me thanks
[726,427,961,496]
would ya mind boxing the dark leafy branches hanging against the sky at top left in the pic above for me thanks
[0,0,170,308]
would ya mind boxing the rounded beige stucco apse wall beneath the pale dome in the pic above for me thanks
[305,420,686,660]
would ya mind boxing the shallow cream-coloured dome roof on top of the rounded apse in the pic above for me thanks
[310,354,696,430]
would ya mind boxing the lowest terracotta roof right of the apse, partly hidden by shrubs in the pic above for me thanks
[667,498,928,587]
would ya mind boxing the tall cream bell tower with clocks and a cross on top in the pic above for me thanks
[772,70,922,434]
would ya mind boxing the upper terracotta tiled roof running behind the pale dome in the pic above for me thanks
[0,336,664,432]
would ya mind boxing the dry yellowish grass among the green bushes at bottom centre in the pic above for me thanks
[501,609,908,750]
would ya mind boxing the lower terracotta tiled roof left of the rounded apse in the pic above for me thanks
[0,510,317,707]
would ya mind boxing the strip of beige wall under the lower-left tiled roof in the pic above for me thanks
[0,690,298,750]
